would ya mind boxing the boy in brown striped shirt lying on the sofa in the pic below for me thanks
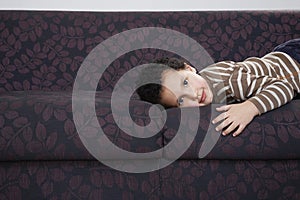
[137,39,300,136]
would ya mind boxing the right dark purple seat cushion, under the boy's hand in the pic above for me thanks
[164,100,300,159]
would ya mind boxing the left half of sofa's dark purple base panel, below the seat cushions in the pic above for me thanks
[0,161,161,200]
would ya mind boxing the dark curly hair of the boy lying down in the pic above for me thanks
[137,58,185,104]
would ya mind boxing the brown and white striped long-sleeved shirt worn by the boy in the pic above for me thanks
[199,52,300,114]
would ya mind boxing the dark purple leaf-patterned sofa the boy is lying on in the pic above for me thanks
[0,10,300,200]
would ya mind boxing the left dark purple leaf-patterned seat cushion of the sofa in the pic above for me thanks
[0,91,162,161]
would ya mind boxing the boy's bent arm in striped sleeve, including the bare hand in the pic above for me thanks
[213,65,294,136]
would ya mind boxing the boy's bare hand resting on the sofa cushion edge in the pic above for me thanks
[212,101,259,136]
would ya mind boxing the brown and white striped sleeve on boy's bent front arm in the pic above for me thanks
[229,67,294,114]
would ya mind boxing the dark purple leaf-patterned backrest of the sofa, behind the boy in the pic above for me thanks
[0,11,300,92]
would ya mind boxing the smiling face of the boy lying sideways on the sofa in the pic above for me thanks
[161,64,213,107]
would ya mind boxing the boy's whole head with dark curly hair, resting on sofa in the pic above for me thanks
[137,58,213,108]
